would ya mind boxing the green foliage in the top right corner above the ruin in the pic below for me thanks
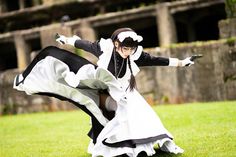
[225,0,236,18]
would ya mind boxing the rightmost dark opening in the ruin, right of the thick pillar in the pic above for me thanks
[173,4,226,42]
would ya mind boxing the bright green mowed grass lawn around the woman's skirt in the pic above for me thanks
[0,101,236,157]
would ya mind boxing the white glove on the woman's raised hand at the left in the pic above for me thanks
[55,34,81,46]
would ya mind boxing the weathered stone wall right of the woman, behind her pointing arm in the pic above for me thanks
[137,38,236,103]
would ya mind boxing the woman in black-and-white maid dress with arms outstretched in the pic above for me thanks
[14,28,193,157]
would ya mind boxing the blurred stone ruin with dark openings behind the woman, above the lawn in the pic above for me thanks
[0,0,236,115]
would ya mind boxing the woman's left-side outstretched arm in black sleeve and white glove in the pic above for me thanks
[56,34,102,57]
